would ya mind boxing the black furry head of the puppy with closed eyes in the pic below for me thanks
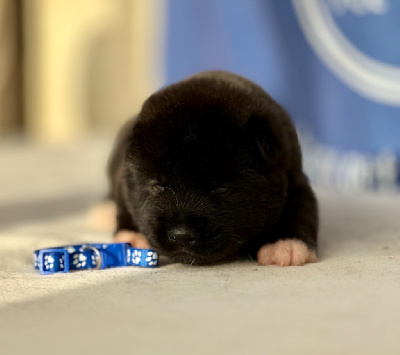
[124,76,287,264]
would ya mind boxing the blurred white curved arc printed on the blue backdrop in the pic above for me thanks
[292,0,400,106]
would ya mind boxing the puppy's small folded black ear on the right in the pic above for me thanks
[246,116,285,167]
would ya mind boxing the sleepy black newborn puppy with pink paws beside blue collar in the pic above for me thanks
[109,72,318,266]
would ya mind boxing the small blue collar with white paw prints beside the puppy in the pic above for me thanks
[33,243,158,275]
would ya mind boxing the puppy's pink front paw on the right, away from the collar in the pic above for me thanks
[257,239,317,266]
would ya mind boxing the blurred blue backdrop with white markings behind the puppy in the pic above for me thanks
[166,0,400,189]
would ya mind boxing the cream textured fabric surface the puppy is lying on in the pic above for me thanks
[0,142,400,354]
